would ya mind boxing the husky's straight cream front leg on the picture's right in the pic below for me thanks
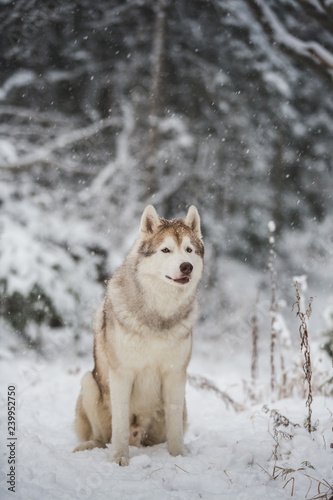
[163,372,186,456]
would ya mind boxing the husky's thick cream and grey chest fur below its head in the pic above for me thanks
[104,270,196,371]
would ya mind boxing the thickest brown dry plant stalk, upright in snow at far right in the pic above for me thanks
[293,281,313,432]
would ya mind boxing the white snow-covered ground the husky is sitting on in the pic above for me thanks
[0,328,333,500]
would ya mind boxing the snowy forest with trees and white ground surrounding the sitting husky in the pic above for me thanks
[0,0,333,500]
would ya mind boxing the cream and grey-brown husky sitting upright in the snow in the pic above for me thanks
[74,205,204,465]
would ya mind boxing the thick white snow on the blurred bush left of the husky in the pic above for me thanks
[0,180,103,338]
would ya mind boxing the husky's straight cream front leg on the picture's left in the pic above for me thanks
[109,371,134,465]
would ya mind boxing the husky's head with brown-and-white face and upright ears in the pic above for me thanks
[138,205,204,288]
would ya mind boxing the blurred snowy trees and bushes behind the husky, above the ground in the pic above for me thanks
[0,0,333,368]
